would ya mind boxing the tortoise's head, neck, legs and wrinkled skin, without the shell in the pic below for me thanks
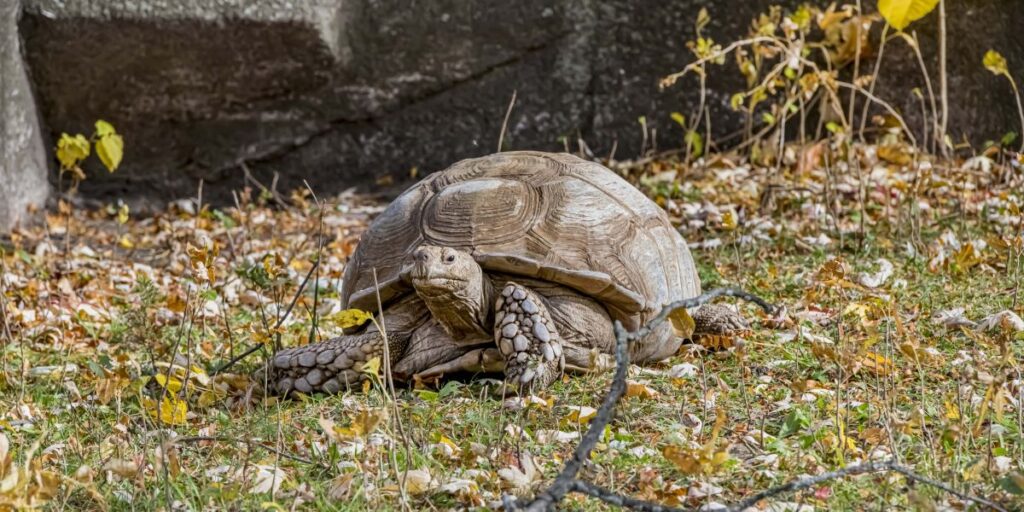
[270,246,746,394]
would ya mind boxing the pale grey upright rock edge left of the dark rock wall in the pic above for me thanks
[0,1,49,230]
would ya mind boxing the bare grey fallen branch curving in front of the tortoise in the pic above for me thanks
[503,288,1006,512]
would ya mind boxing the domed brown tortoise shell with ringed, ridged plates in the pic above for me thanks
[341,152,700,329]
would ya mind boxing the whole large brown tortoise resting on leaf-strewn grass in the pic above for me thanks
[269,152,746,394]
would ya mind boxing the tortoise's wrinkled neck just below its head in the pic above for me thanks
[417,272,495,340]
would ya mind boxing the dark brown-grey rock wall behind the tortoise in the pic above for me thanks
[6,0,1024,224]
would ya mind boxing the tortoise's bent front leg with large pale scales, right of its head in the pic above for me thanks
[495,283,565,388]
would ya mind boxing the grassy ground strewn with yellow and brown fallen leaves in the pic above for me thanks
[0,147,1024,510]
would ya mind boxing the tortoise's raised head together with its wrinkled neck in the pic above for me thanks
[407,246,494,339]
